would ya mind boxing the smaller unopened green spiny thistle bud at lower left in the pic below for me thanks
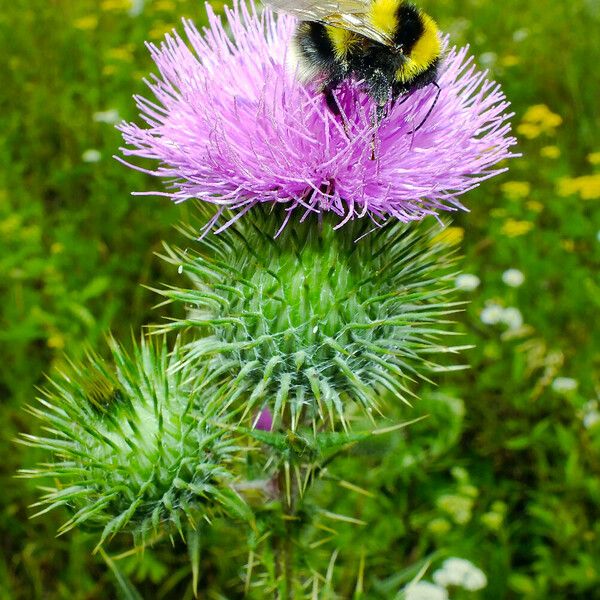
[22,341,243,544]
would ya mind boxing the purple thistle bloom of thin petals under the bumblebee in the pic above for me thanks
[119,2,515,227]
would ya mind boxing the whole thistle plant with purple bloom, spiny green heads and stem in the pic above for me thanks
[23,2,514,600]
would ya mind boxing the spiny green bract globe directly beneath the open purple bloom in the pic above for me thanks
[161,210,457,428]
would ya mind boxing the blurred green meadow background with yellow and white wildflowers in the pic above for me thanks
[0,0,600,600]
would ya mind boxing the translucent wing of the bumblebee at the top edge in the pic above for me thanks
[263,0,394,46]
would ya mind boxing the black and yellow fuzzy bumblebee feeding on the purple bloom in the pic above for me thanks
[265,0,441,131]
